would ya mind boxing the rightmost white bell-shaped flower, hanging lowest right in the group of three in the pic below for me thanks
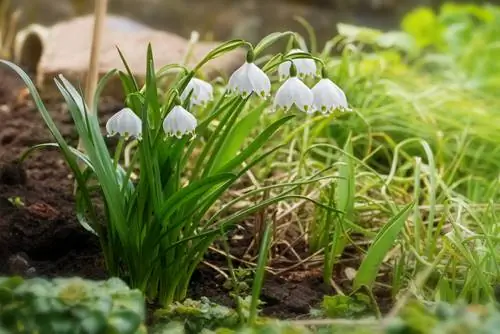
[311,78,350,113]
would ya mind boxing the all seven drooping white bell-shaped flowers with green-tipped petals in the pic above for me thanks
[106,49,350,138]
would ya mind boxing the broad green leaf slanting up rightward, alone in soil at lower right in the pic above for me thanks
[353,202,415,290]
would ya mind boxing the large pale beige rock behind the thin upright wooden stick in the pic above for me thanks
[14,15,244,97]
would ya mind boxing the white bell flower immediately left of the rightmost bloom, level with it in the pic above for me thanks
[274,77,314,113]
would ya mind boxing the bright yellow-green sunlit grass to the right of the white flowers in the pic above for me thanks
[225,4,500,314]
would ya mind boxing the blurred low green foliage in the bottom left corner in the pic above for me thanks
[0,277,146,334]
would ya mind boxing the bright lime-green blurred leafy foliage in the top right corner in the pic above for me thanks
[402,3,500,92]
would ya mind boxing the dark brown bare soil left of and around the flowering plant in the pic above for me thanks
[0,67,390,318]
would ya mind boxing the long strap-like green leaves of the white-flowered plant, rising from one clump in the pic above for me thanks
[3,33,338,305]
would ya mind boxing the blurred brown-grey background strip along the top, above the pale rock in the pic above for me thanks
[11,0,500,42]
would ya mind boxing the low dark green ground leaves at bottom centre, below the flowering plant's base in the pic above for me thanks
[155,297,239,333]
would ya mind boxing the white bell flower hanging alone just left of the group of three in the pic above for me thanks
[228,62,271,98]
